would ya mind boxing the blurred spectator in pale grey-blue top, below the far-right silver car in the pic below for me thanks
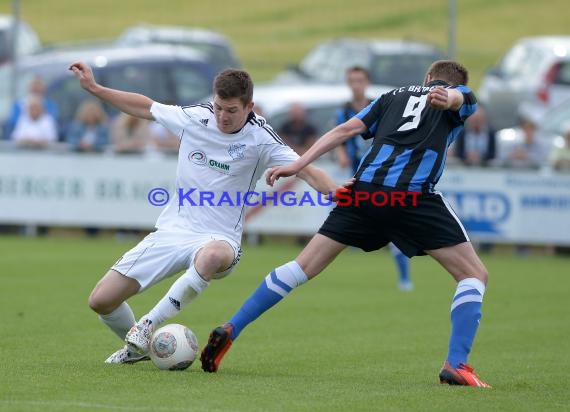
[499,116,546,169]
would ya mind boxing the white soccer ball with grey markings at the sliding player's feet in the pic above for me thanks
[150,323,198,371]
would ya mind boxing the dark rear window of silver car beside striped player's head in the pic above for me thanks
[370,54,434,86]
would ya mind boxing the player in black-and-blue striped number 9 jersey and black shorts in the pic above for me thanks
[201,60,490,388]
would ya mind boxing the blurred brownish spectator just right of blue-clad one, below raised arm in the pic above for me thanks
[111,113,151,154]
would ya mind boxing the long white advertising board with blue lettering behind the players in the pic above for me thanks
[0,152,570,245]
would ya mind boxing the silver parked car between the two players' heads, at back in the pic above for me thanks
[276,38,445,87]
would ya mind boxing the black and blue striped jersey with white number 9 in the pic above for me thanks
[355,80,477,193]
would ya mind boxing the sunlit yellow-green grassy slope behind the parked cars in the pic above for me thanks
[0,0,568,86]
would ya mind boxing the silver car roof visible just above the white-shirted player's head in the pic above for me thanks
[116,25,241,71]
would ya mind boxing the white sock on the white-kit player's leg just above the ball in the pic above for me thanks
[141,265,210,330]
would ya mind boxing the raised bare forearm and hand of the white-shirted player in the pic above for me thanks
[69,62,154,120]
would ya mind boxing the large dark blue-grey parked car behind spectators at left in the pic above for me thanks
[0,45,216,138]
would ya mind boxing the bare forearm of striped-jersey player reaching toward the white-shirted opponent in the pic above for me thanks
[266,117,367,186]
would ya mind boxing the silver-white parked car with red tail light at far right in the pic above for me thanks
[477,36,570,130]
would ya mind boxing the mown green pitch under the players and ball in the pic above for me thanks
[0,237,570,412]
